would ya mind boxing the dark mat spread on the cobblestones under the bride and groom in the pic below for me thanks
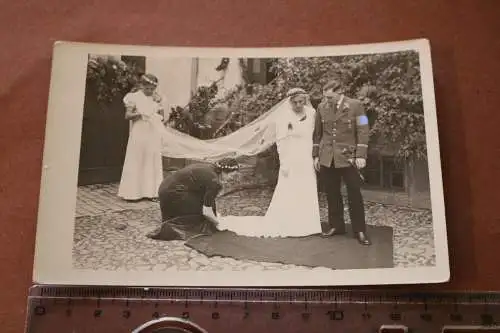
[186,222,394,269]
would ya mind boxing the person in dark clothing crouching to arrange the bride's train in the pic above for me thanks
[149,158,239,241]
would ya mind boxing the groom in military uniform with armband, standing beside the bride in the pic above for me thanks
[313,80,371,245]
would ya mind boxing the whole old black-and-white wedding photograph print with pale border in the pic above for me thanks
[35,40,449,286]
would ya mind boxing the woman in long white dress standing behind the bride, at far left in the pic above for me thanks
[118,74,164,201]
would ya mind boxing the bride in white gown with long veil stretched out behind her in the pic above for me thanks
[163,88,322,237]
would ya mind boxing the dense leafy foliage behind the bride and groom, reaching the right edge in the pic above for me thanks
[199,51,426,158]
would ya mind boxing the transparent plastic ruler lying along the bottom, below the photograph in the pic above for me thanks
[26,286,500,333]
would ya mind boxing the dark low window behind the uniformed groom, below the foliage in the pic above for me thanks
[363,154,406,191]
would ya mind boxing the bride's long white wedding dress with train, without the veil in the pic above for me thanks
[218,107,322,237]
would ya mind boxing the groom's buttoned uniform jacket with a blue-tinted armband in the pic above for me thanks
[313,96,369,168]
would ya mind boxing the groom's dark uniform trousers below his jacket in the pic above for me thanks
[320,163,366,233]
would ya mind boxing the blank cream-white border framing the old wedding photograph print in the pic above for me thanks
[33,39,450,287]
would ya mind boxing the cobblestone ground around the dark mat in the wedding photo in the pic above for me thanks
[73,185,435,270]
